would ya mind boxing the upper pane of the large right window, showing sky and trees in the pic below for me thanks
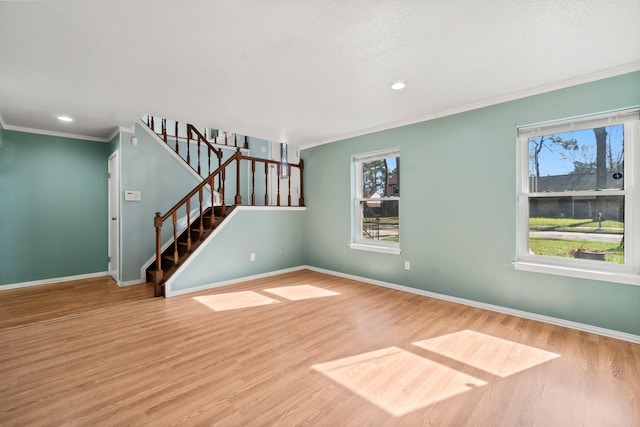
[528,125,624,193]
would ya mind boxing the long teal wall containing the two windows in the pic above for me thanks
[302,72,640,335]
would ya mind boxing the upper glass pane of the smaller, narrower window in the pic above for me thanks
[362,157,400,199]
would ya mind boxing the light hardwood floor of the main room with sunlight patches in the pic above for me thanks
[0,271,640,427]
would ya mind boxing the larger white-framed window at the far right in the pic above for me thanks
[515,109,640,285]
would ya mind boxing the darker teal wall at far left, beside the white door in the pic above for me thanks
[0,130,108,285]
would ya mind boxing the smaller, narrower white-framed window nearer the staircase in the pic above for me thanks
[349,149,400,254]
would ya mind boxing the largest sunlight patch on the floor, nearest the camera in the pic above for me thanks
[312,347,486,417]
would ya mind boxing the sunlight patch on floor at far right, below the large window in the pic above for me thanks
[413,330,560,378]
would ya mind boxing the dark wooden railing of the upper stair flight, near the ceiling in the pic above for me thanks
[142,115,249,178]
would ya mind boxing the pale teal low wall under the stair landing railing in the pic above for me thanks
[171,209,305,291]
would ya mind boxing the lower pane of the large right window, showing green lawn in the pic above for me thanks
[529,196,624,264]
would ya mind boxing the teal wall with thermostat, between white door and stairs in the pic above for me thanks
[120,124,208,282]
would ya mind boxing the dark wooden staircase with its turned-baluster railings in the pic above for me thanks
[143,116,304,297]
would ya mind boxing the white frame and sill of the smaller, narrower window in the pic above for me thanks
[349,147,402,255]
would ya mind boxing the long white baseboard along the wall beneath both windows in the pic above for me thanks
[299,265,640,344]
